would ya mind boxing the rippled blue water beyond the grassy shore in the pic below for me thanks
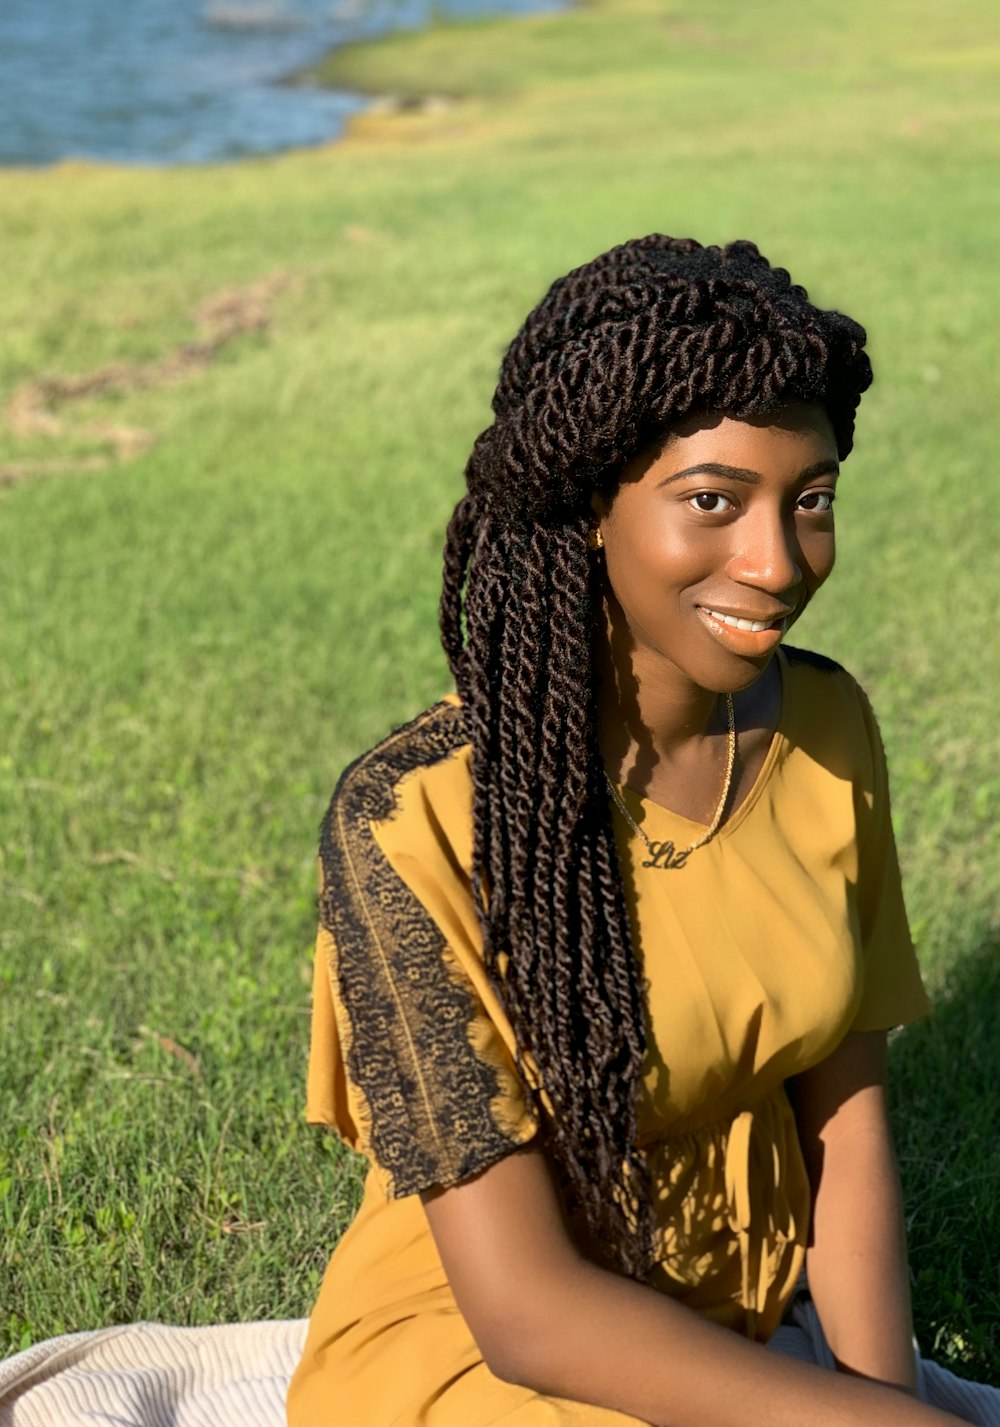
[0,0,553,166]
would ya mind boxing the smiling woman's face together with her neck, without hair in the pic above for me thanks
[592,402,839,821]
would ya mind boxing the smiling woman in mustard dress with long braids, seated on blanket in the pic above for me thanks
[290,235,981,1427]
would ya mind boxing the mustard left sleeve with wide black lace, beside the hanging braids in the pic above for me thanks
[307,705,536,1199]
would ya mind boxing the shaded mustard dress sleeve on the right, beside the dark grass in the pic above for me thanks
[852,686,930,1030]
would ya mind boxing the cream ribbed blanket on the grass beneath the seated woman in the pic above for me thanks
[0,1299,1000,1427]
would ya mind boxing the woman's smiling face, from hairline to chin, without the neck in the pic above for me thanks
[593,402,839,692]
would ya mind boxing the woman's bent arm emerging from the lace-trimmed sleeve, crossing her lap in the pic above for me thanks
[424,1150,957,1427]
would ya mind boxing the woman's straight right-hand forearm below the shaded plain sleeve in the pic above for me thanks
[789,1030,916,1391]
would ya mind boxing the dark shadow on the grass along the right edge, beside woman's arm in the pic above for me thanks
[889,929,1000,1386]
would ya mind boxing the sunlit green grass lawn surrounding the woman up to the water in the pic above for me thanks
[0,0,1000,1383]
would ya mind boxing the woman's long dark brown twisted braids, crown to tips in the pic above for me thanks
[441,234,872,1277]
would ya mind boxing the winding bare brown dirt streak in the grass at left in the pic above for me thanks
[0,273,295,485]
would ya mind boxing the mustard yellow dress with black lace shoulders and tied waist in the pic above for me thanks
[288,649,926,1427]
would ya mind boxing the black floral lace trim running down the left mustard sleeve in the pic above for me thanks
[320,704,527,1197]
